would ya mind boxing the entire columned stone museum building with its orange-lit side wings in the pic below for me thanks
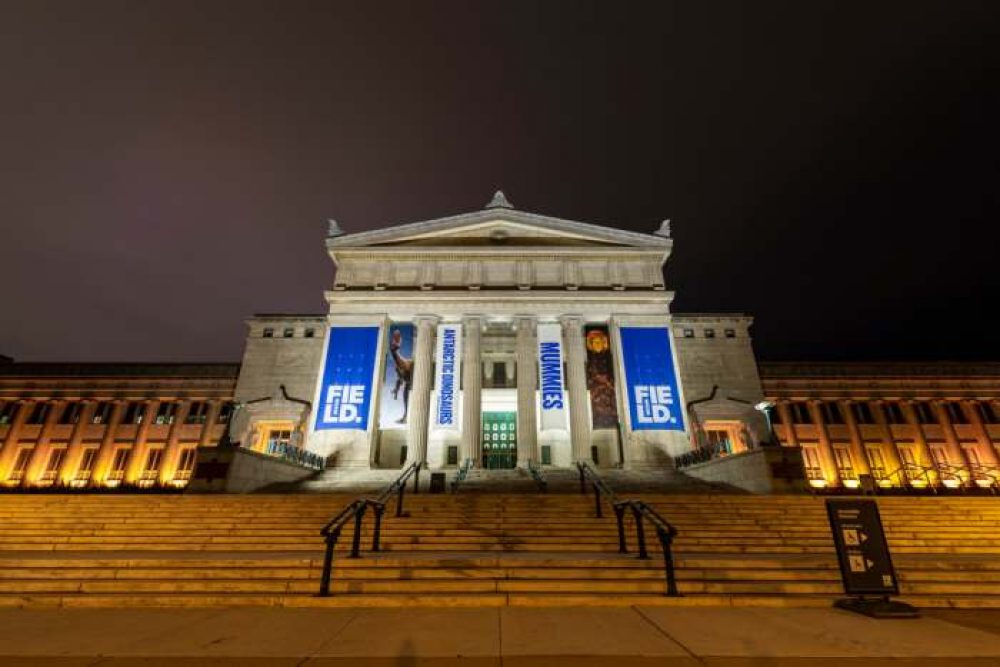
[0,192,1000,489]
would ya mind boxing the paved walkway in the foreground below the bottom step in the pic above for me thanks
[0,607,1000,667]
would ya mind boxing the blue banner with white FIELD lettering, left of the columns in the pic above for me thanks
[316,327,378,431]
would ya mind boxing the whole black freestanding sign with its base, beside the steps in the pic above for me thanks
[826,499,919,618]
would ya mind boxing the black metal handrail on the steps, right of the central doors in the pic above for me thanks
[576,461,680,597]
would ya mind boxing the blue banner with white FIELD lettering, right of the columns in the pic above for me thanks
[620,327,684,431]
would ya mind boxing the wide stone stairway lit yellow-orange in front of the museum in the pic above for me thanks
[0,493,1000,607]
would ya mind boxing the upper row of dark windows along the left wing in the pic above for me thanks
[0,401,233,425]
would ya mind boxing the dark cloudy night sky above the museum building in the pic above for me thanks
[0,0,1000,361]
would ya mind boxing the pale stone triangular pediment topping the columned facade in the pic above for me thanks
[327,209,670,249]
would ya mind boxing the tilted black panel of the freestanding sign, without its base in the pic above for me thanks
[826,499,899,596]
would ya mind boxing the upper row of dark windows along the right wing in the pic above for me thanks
[772,401,1000,424]
